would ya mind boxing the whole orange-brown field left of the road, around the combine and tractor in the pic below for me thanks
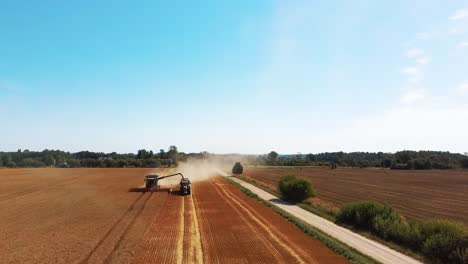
[0,169,347,263]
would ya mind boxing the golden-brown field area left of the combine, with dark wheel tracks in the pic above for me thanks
[0,169,167,263]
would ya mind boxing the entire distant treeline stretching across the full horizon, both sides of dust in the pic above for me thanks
[0,146,468,170]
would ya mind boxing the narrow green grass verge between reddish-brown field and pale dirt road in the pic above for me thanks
[224,177,380,264]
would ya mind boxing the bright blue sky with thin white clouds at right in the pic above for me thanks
[0,0,468,153]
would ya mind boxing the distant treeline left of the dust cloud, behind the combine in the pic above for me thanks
[0,146,209,168]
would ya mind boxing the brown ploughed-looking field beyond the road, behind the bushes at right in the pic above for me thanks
[244,167,468,223]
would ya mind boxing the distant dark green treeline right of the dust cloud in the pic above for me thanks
[249,150,468,170]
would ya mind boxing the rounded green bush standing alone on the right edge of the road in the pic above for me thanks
[278,175,315,203]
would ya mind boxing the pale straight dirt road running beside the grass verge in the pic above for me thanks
[232,177,420,264]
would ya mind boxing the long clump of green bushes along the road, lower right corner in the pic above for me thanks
[336,201,468,263]
